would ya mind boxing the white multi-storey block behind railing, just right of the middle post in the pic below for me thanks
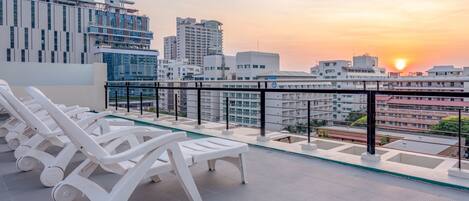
[254,71,332,131]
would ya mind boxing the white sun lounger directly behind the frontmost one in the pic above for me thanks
[0,87,146,187]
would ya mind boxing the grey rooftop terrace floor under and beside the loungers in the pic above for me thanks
[0,144,469,201]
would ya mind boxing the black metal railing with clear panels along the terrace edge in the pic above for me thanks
[105,79,469,168]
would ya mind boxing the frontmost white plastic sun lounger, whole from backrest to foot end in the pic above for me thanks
[27,87,249,200]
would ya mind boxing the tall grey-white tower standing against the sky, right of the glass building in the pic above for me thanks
[176,17,223,66]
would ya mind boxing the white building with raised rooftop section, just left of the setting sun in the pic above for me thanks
[311,54,386,123]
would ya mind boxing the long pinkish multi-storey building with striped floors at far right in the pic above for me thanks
[376,66,469,132]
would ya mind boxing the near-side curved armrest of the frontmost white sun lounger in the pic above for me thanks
[97,132,186,165]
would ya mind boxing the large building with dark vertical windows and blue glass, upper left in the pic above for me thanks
[0,0,158,88]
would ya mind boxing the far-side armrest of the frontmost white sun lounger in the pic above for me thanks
[95,127,165,144]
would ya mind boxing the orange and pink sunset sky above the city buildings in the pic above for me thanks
[135,0,469,72]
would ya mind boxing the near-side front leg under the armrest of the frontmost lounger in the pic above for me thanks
[168,145,202,201]
